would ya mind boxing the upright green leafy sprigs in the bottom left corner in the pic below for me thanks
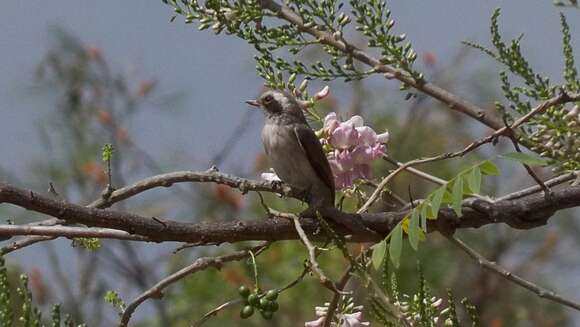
[0,256,86,327]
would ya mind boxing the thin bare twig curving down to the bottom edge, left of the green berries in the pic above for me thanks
[119,242,270,326]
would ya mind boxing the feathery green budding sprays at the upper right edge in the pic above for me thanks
[464,9,580,170]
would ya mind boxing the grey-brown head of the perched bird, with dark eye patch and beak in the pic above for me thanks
[246,90,305,123]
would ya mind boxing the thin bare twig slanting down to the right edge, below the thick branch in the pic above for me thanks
[448,236,580,311]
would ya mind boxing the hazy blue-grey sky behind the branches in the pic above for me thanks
[0,0,580,326]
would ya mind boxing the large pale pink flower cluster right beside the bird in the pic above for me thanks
[319,112,389,189]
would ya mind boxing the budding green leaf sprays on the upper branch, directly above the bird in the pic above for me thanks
[164,0,423,89]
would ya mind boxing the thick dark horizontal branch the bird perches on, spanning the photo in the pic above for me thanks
[0,181,580,245]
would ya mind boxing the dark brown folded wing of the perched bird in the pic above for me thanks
[294,124,335,198]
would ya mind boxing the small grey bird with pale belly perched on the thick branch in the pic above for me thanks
[246,90,335,210]
